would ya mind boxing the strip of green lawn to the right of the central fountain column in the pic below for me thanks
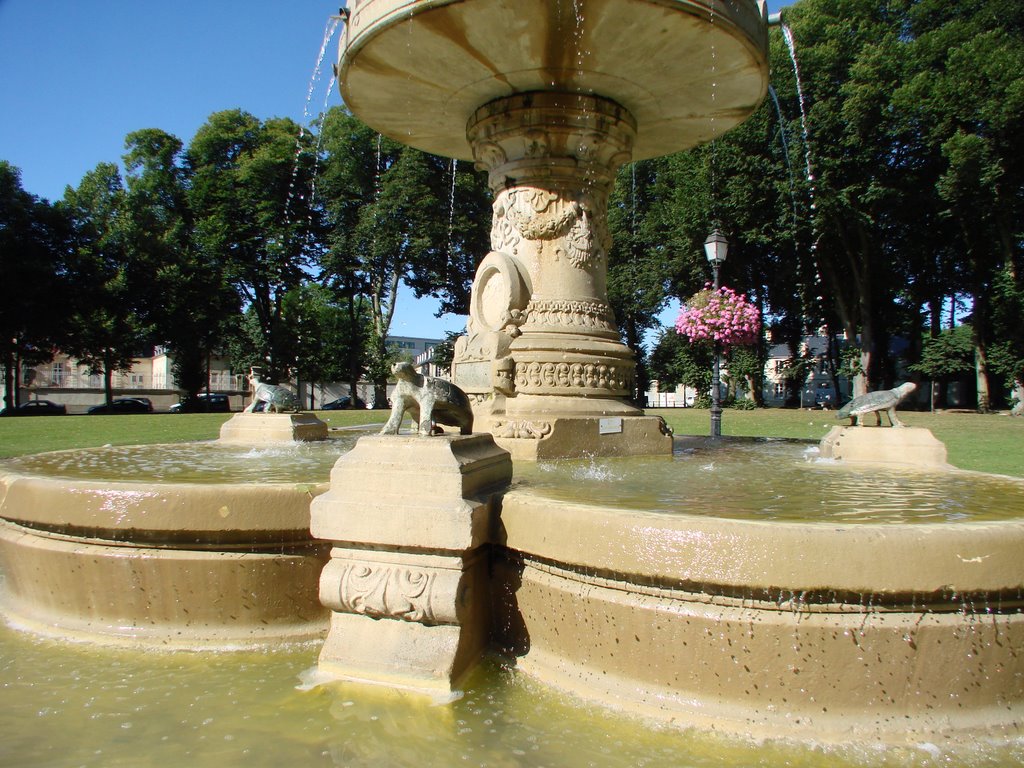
[647,408,1024,477]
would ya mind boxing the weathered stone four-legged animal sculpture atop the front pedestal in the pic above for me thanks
[381,362,473,435]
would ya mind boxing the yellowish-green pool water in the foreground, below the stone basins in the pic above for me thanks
[0,627,1024,768]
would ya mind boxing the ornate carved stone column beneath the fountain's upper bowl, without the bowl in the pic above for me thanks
[453,92,672,460]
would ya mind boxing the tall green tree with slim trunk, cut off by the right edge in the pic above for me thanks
[893,0,1024,411]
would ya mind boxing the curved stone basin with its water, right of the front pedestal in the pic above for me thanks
[495,441,1024,743]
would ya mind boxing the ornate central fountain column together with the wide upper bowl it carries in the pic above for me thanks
[338,0,768,459]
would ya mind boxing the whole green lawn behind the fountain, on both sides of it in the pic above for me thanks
[0,408,1024,477]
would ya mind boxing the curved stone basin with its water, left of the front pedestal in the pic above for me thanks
[0,437,354,648]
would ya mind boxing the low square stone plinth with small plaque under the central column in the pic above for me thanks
[489,415,672,461]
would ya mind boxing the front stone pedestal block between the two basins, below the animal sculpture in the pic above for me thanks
[310,434,512,694]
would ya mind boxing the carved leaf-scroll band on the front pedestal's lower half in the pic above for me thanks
[338,562,437,624]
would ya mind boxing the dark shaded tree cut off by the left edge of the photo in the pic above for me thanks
[0,161,68,409]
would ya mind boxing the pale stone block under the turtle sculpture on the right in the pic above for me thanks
[820,427,949,469]
